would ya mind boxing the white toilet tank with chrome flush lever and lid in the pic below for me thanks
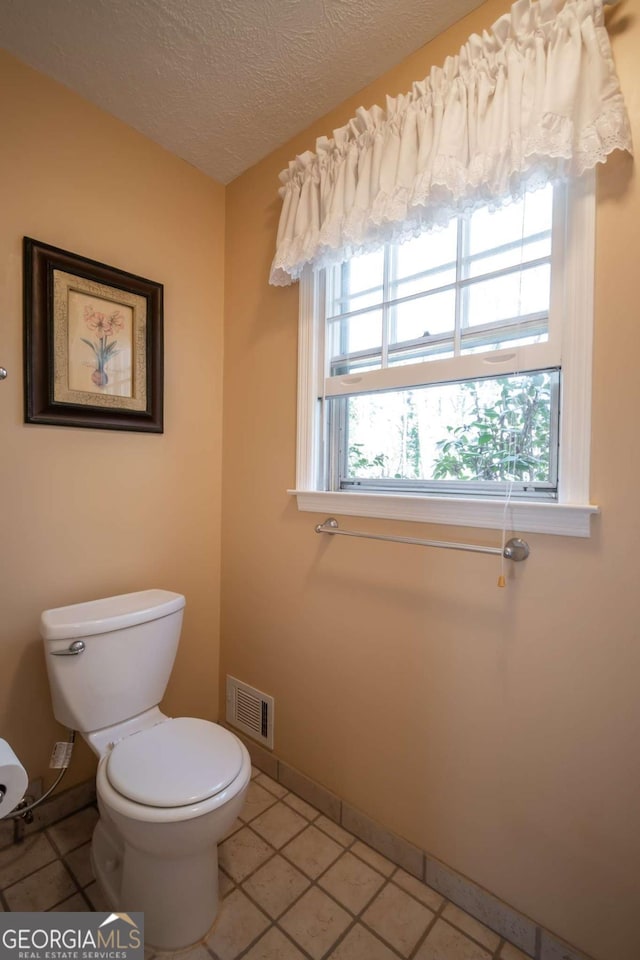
[40,590,185,733]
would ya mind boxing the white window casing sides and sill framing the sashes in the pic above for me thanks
[289,172,599,537]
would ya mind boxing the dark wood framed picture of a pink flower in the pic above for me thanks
[24,237,163,433]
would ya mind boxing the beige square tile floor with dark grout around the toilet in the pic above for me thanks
[0,770,528,960]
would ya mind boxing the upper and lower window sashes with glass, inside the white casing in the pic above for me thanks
[325,185,561,498]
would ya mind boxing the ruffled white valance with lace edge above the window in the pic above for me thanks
[270,0,631,286]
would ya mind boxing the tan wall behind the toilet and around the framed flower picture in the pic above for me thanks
[0,54,224,784]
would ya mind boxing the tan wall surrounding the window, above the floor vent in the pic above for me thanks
[220,0,640,960]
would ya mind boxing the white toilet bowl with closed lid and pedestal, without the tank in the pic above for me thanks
[88,710,251,950]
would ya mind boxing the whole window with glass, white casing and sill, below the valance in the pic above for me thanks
[296,176,596,536]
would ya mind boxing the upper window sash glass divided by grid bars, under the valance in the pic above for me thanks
[327,186,558,381]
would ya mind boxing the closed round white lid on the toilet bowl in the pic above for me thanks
[106,717,242,807]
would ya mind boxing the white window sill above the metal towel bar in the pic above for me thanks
[288,490,600,537]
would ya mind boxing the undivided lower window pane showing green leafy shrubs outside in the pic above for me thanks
[340,370,559,487]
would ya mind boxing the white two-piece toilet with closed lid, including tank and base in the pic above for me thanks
[41,590,251,950]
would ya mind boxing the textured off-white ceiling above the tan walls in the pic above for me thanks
[0,0,482,183]
